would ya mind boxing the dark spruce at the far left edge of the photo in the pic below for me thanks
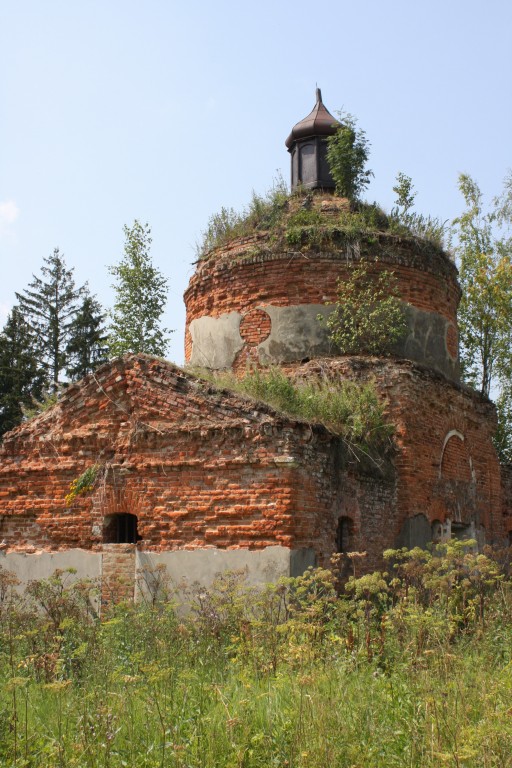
[0,307,44,435]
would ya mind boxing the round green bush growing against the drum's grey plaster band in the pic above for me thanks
[319,263,407,355]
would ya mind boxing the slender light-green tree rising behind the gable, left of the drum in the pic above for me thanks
[109,220,169,356]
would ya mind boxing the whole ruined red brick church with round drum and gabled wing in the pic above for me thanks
[0,91,512,595]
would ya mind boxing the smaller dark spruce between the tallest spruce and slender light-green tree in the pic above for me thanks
[66,293,108,381]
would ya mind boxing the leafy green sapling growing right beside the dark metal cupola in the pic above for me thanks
[327,112,373,201]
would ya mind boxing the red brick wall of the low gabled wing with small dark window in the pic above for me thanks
[0,356,400,568]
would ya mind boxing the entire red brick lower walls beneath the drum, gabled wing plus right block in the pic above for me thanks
[0,356,506,568]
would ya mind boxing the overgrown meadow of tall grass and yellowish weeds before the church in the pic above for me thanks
[0,542,512,768]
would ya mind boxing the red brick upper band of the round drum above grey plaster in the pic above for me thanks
[185,235,460,360]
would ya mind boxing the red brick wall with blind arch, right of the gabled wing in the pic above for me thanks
[299,357,504,544]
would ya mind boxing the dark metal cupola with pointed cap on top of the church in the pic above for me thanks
[285,88,339,191]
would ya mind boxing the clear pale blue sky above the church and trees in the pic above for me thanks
[0,0,512,363]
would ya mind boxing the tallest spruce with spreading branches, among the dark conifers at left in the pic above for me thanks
[16,248,84,391]
